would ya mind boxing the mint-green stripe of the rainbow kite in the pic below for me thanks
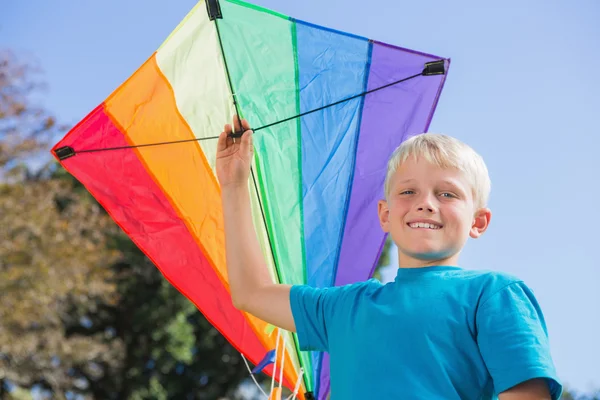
[218,0,314,390]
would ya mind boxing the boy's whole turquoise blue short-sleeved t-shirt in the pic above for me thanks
[290,266,562,400]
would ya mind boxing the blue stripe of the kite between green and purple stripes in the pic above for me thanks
[296,21,370,392]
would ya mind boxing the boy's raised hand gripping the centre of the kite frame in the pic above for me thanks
[217,117,254,188]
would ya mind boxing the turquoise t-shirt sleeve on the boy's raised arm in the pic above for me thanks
[290,285,343,351]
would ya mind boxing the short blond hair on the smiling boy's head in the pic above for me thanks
[385,133,491,208]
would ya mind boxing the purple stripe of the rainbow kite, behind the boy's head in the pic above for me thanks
[318,42,448,400]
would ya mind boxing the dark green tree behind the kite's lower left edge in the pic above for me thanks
[71,233,253,400]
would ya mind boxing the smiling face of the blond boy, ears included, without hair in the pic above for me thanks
[379,157,491,267]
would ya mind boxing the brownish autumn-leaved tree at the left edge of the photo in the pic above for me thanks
[0,47,118,398]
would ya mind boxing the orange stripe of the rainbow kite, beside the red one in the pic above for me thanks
[105,56,297,385]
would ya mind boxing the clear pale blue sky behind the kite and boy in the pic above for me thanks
[0,0,600,396]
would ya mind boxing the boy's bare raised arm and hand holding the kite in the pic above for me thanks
[217,118,296,332]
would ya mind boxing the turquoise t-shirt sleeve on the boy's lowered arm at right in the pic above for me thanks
[477,282,562,399]
